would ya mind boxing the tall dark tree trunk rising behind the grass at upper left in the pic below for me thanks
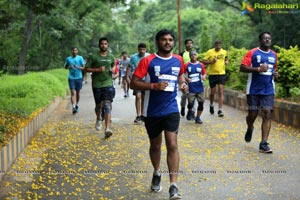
[18,9,34,75]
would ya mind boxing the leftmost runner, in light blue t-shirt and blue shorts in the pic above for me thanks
[65,47,85,114]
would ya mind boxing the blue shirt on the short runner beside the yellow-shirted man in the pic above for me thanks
[185,62,206,94]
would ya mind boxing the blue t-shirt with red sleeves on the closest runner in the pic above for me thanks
[134,54,184,117]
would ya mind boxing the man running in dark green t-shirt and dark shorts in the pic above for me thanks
[86,37,115,137]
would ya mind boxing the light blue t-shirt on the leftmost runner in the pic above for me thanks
[65,55,85,79]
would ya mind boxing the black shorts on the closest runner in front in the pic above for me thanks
[145,112,180,139]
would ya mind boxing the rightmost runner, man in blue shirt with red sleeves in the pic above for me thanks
[240,32,278,153]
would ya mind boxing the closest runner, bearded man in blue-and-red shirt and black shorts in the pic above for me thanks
[130,29,188,199]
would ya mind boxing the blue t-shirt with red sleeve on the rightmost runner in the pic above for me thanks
[242,48,277,95]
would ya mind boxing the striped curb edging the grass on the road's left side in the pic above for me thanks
[0,97,63,181]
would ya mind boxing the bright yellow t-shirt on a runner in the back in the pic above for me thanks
[204,48,227,75]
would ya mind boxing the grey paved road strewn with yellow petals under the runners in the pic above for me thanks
[0,75,300,200]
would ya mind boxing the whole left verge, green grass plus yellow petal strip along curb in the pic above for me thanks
[0,69,68,147]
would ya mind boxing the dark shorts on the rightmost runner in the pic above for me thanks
[247,94,274,111]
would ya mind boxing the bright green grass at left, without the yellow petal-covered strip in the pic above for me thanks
[0,69,68,117]
